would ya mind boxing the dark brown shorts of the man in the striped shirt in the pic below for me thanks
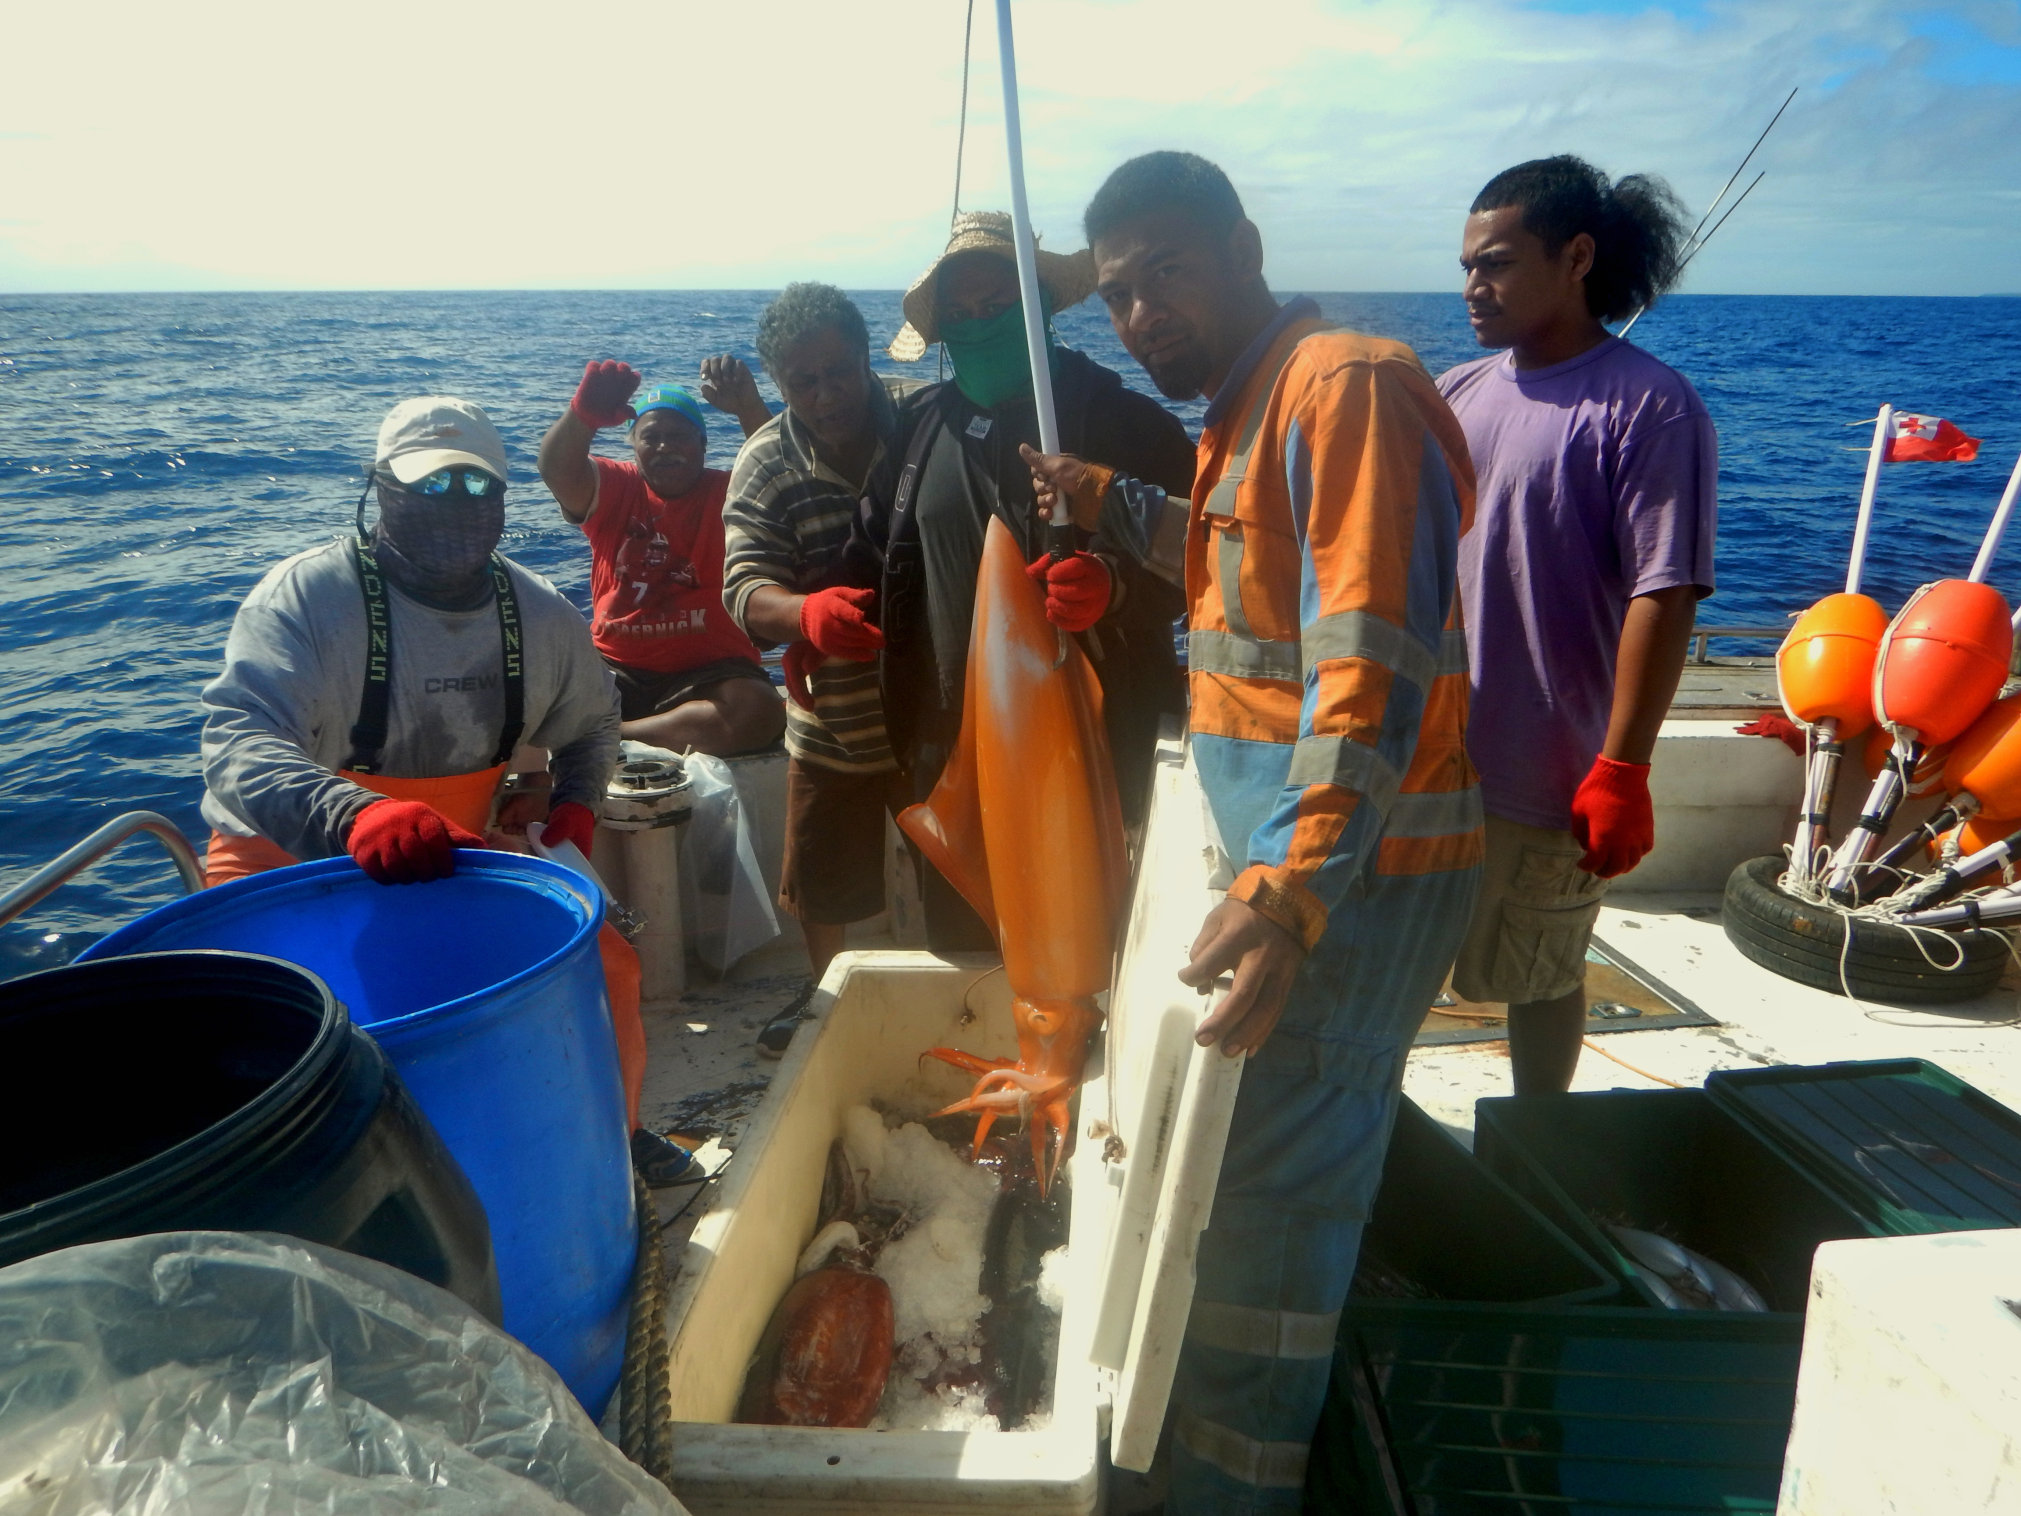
[778,758,911,926]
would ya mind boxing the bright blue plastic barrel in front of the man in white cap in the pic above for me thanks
[83,851,639,1419]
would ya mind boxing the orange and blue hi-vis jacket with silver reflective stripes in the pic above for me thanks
[1186,319,1483,946]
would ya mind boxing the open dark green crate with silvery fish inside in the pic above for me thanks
[1473,1089,1882,1320]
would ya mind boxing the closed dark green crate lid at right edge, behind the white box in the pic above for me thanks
[1706,1057,2021,1237]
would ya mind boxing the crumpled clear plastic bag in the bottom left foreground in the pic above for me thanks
[0,1231,683,1516]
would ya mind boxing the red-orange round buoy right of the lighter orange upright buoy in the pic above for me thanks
[1873,578,2015,746]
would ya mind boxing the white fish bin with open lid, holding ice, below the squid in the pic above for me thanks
[667,738,1241,1516]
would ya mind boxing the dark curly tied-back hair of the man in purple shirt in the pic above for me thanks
[1471,154,1690,321]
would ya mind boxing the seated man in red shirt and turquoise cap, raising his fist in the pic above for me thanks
[540,362,786,756]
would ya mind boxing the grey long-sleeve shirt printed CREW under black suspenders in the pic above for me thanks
[204,542,618,859]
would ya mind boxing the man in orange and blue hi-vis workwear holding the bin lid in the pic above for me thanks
[1027,152,1481,1516]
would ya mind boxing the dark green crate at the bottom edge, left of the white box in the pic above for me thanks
[1306,1302,1803,1516]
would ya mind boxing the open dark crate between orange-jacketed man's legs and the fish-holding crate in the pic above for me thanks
[1358,1096,1621,1306]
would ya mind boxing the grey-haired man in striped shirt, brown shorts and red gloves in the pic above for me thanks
[724,283,909,1002]
